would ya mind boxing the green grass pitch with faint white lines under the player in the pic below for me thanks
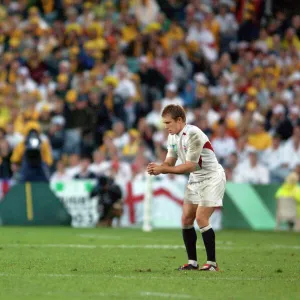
[0,227,300,300]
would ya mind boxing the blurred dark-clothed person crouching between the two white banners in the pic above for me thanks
[91,176,123,227]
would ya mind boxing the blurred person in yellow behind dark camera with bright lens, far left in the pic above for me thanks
[11,121,53,183]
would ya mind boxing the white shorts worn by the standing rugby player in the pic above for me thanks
[184,170,226,207]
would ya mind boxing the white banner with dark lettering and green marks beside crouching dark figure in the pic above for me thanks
[50,180,99,227]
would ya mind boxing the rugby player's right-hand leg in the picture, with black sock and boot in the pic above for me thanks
[196,206,217,271]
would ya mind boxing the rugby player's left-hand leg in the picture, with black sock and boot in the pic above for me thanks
[179,203,198,270]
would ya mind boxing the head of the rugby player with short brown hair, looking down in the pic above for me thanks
[161,104,186,134]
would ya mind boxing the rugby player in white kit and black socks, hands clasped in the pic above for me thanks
[147,104,226,271]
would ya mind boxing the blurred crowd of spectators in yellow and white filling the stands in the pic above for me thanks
[0,0,300,183]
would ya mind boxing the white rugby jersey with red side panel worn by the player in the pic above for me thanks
[167,124,222,182]
